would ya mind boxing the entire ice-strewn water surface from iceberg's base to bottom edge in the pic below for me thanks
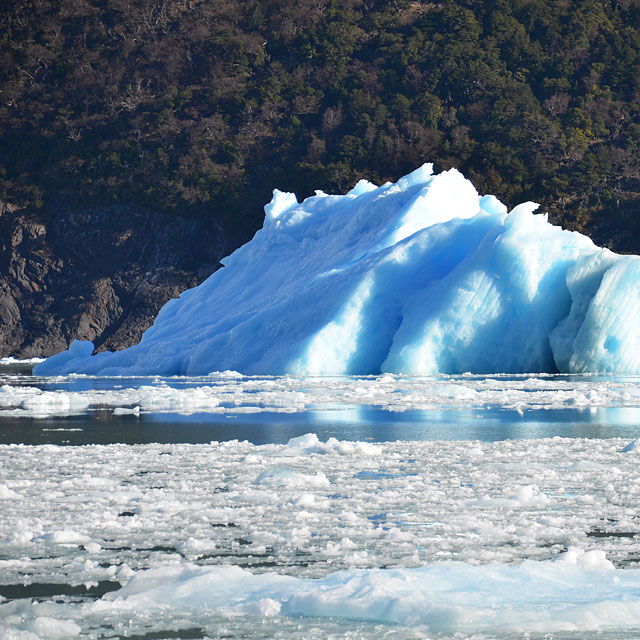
[0,363,640,640]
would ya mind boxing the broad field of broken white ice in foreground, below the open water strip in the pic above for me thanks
[0,434,640,640]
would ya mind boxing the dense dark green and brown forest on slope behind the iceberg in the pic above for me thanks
[0,0,640,252]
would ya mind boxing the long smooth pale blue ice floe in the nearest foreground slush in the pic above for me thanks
[97,556,640,634]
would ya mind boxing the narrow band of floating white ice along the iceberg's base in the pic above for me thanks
[0,371,640,418]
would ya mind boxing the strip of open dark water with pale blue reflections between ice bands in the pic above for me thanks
[0,407,640,445]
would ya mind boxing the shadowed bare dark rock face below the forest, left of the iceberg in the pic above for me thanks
[0,206,233,358]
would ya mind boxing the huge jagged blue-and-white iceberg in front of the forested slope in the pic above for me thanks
[34,164,640,376]
